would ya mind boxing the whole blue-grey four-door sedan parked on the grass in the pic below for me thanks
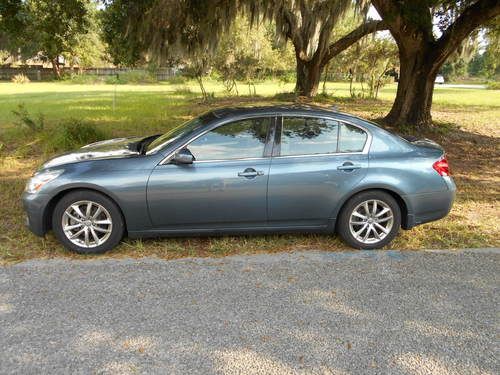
[23,106,455,253]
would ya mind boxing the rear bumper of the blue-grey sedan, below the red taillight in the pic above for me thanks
[403,177,456,229]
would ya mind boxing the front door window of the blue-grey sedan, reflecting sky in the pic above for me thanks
[188,118,271,160]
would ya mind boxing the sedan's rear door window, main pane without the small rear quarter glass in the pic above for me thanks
[281,117,339,156]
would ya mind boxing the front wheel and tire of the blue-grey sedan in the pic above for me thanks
[52,190,125,254]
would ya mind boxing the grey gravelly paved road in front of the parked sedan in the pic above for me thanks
[0,249,500,375]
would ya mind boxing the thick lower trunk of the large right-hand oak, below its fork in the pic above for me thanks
[385,48,440,127]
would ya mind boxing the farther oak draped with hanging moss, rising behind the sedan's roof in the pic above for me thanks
[107,0,385,97]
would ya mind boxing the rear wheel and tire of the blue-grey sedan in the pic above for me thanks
[337,190,401,250]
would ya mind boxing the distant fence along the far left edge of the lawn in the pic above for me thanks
[0,66,178,81]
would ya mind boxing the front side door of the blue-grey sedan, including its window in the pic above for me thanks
[148,117,275,230]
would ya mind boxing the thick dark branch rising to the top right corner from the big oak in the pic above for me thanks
[435,0,500,61]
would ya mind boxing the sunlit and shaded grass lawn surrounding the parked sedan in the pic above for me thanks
[0,82,500,262]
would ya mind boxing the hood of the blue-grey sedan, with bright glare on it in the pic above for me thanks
[41,137,143,169]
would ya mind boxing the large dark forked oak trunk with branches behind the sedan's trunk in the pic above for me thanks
[372,0,500,127]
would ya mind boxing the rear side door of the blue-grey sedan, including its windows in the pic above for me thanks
[268,116,369,227]
